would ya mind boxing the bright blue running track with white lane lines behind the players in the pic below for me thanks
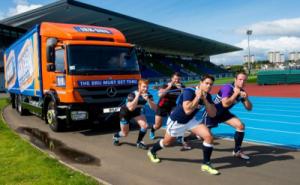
[146,87,300,150]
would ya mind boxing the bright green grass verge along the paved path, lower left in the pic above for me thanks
[0,99,99,185]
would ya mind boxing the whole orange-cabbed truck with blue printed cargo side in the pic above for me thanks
[4,22,141,131]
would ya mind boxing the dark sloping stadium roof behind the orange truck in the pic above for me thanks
[0,0,241,57]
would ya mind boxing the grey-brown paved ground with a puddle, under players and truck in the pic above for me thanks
[4,107,300,185]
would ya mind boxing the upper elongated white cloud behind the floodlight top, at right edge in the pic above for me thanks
[236,17,300,36]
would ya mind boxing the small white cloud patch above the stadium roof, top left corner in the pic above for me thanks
[6,0,43,17]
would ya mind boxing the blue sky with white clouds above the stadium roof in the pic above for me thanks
[0,0,300,65]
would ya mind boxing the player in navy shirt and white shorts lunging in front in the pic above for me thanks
[147,75,219,175]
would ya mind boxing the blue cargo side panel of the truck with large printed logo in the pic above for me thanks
[4,26,42,97]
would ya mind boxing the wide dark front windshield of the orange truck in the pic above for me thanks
[67,45,139,75]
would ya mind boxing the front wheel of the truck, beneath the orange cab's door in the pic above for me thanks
[46,100,64,132]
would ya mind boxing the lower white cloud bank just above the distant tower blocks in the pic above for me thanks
[211,37,300,64]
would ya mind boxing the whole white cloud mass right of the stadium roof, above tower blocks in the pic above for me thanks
[211,18,300,64]
